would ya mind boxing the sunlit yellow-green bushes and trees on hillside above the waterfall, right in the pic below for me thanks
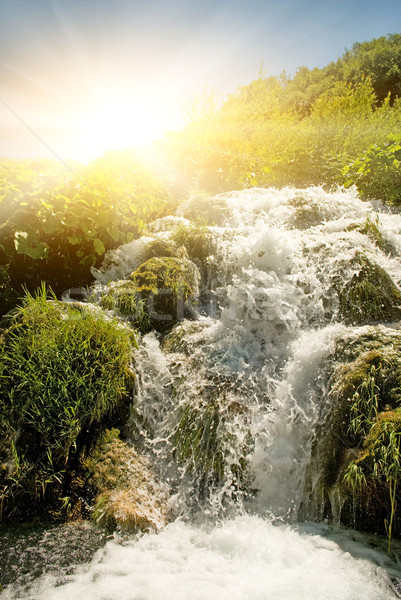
[160,35,401,198]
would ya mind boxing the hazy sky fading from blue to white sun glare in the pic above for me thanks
[0,0,401,161]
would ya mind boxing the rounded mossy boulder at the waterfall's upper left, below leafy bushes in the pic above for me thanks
[130,257,200,331]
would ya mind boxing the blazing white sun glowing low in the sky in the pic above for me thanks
[71,87,183,160]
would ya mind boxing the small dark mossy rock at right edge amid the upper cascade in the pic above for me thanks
[337,254,401,325]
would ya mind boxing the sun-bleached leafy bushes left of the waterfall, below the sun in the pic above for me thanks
[0,152,172,311]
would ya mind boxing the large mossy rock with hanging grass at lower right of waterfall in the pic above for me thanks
[303,327,401,539]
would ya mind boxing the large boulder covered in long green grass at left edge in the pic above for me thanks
[0,290,136,520]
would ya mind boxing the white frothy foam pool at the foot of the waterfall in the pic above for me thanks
[2,516,396,600]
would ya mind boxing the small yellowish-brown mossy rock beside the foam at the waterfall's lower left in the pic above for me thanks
[90,429,167,531]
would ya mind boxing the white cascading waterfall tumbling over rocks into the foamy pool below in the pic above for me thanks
[0,188,401,600]
